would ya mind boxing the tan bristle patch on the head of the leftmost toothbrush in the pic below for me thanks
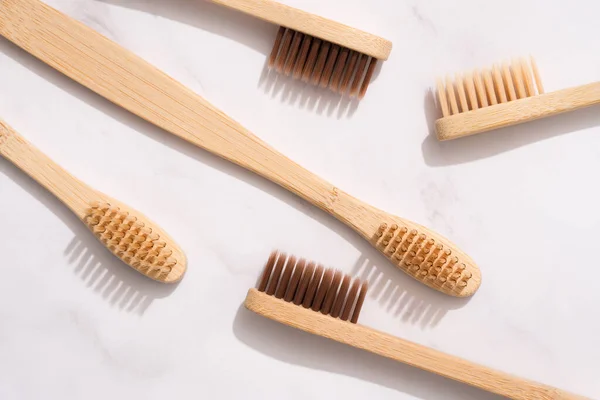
[83,202,179,280]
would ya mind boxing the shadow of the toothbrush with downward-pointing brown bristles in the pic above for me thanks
[97,0,370,119]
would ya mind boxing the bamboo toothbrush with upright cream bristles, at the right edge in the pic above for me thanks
[435,57,600,140]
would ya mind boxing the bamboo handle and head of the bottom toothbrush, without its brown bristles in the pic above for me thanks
[244,289,585,400]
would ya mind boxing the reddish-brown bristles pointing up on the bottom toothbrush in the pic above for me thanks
[257,251,368,323]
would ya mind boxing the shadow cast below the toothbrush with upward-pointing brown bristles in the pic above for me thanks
[233,305,503,400]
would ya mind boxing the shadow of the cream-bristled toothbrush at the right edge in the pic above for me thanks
[421,90,600,167]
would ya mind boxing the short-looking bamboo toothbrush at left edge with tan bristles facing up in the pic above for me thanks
[0,120,186,283]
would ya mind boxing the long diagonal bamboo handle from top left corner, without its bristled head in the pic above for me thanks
[0,0,366,220]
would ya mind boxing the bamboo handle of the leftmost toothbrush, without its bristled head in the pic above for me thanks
[0,120,98,218]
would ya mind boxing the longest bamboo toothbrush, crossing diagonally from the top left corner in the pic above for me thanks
[0,0,481,297]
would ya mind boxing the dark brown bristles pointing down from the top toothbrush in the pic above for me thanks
[268,26,377,98]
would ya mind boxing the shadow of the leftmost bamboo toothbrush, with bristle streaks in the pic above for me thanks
[0,158,176,315]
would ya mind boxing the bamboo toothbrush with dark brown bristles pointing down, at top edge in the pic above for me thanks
[210,0,392,98]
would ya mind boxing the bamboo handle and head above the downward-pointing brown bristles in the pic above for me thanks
[210,0,392,60]
